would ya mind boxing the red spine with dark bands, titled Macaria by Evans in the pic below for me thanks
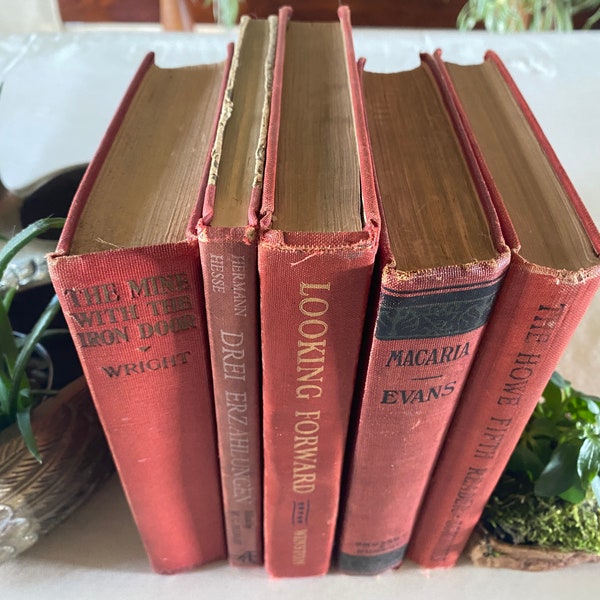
[338,264,508,574]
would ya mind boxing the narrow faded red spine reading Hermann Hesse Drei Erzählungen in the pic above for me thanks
[199,227,262,566]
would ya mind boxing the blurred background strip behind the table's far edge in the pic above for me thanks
[0,0,600,33]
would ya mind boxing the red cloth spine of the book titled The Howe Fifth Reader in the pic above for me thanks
[408,255,598,567]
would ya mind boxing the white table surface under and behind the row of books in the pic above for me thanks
[0,26,600,600]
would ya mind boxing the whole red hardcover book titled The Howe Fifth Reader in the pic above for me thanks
[408,53,600,567]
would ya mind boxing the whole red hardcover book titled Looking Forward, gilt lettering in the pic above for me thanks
[258,7,379,577]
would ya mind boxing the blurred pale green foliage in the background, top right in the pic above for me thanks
[456,0,600,33]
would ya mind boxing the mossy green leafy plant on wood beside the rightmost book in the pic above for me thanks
[469,373,600,570]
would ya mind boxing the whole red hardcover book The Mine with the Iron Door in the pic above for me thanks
[49,54,230,573]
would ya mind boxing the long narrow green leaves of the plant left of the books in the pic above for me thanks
[0,217,65,462]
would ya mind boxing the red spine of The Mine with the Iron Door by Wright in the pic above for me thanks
[49,242,225,573]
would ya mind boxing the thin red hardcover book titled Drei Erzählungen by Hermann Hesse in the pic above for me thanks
[198,16,277,566]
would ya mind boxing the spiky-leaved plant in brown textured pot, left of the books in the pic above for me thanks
[0,218,113,563]
